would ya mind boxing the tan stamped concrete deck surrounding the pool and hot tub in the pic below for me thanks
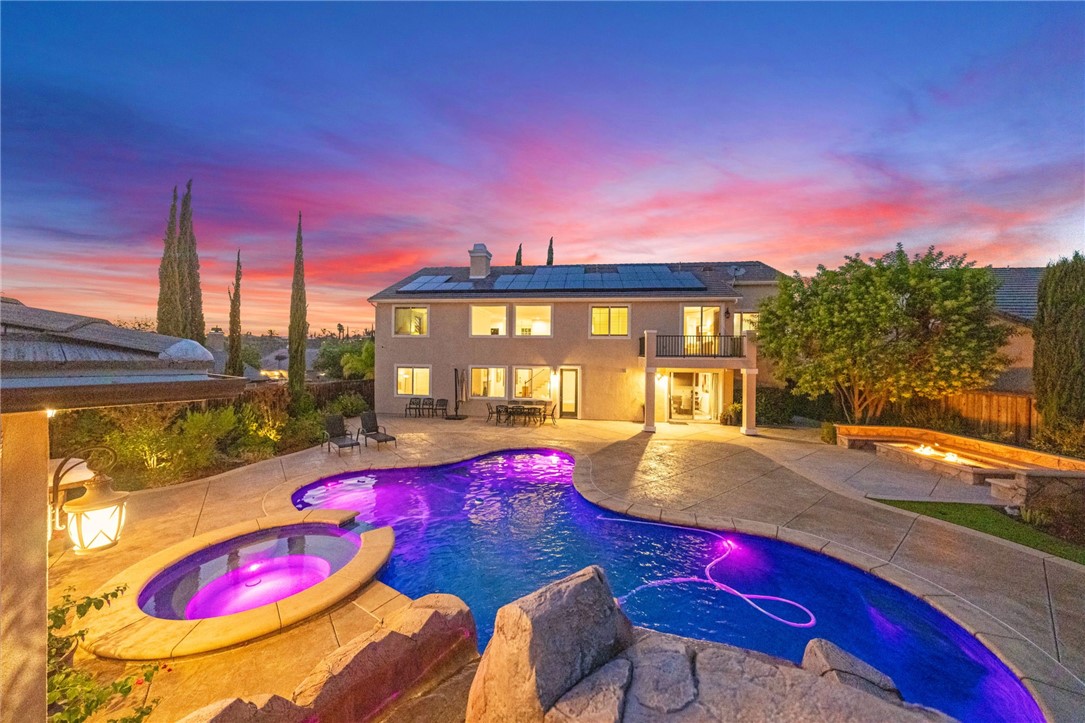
[49,417,1085,721]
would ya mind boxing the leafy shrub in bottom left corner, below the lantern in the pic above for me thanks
[46,585,159,723]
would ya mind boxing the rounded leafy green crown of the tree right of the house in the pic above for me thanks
[757,245,1010,422]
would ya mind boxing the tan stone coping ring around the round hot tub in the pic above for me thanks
[80,508,395,660]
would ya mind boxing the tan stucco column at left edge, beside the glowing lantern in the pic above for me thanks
[0,411,49,721]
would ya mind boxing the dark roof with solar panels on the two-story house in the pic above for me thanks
[369,262,780,302]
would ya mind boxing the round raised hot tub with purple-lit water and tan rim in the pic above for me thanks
[81,509,395,660]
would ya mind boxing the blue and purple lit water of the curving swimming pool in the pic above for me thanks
[293,449,1044,721]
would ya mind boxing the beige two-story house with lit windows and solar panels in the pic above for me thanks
[369,243,779,434]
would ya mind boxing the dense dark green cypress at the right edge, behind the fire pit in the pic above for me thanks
[1032,252,1085,427]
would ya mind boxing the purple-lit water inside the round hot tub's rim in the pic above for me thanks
[138,523,361,620]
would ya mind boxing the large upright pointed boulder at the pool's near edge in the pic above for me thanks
[467,566,634,723]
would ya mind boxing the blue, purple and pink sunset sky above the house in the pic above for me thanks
[0,2,1085,333]
